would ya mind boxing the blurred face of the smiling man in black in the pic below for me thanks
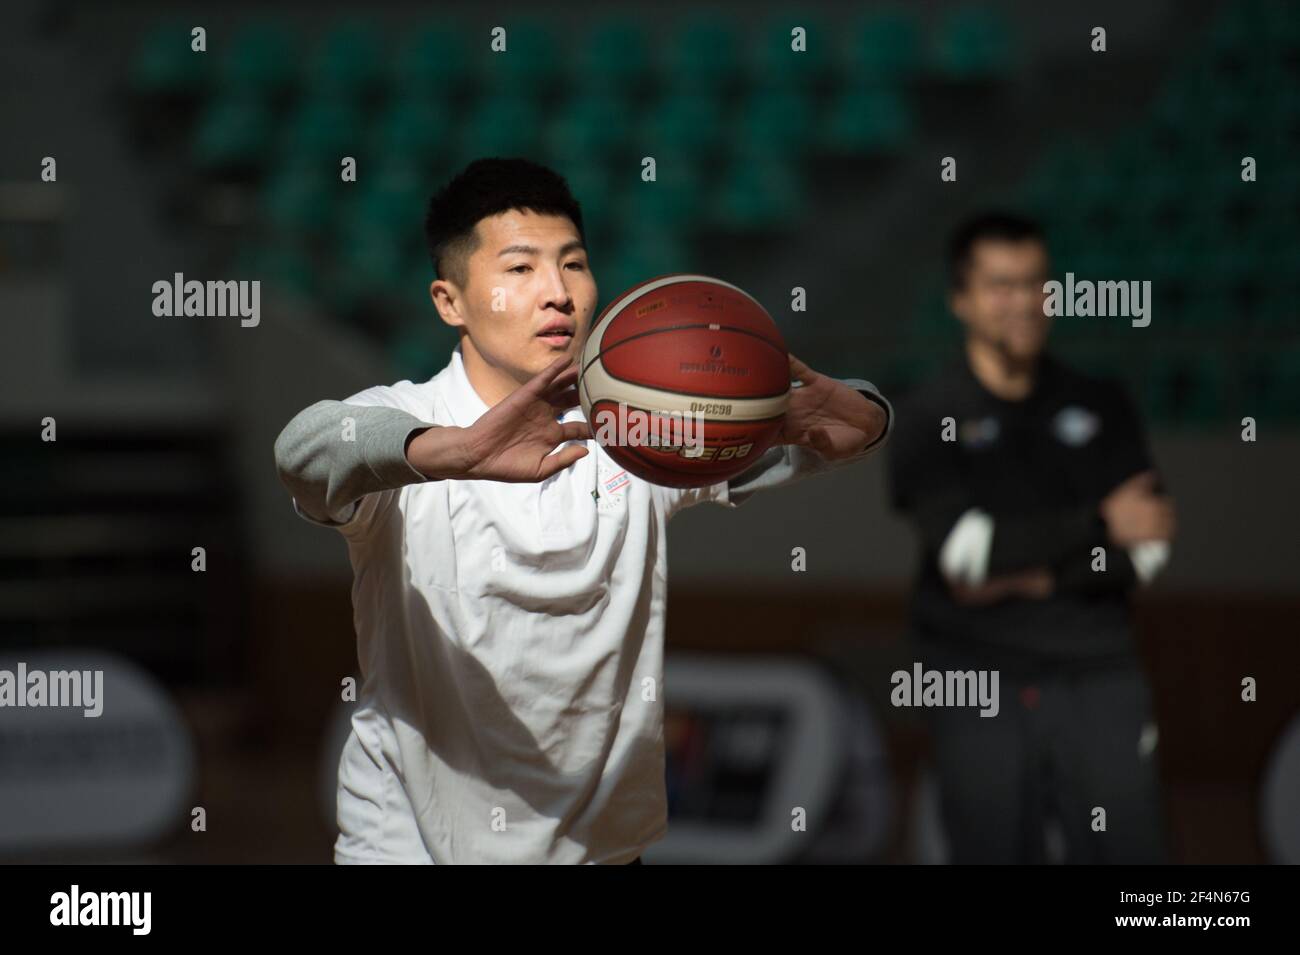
[950,239,1050,361]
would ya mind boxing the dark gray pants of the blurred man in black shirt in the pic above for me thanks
[918,643,1169,864]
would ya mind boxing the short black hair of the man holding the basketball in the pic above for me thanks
[424,157,586,287]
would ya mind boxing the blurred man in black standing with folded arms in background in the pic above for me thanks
[891,214,1174,863]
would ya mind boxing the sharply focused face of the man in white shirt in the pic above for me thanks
[429,209,597,403]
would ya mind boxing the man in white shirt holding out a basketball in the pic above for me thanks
[276,159,892,864]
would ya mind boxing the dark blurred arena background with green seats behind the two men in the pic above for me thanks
[0,0,1300,912]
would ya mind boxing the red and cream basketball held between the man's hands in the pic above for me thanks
[579,274,790,487]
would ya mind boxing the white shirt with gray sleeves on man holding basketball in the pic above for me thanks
[276,348,892,864]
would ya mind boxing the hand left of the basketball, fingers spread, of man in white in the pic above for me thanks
[407,356,592,483]
